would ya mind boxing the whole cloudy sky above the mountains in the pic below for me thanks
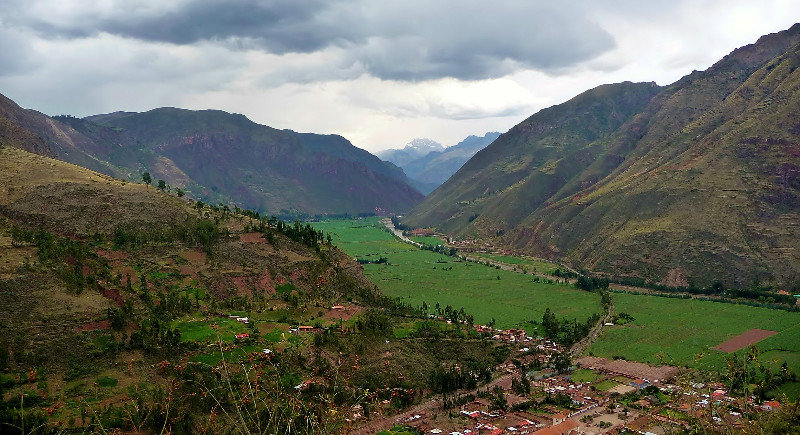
[0,0,800,151]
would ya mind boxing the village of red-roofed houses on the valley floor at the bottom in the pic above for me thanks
[360,325,792,435]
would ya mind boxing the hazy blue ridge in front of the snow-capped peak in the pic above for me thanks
[402,132,500,195]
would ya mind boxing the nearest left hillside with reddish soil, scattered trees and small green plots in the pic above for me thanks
[0,141,510,434]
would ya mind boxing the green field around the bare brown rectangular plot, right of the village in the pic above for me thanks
[590,293,800,372]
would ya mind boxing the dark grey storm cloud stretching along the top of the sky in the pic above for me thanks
[6,0,615,81]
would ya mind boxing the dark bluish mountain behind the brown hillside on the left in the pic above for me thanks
[0,97,422,216]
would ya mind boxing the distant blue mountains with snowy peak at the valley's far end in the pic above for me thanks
[377,132,500,195]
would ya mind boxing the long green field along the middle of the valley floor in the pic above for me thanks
[314,218,600,329]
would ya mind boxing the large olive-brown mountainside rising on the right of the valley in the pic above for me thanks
[404,24,800,286]
